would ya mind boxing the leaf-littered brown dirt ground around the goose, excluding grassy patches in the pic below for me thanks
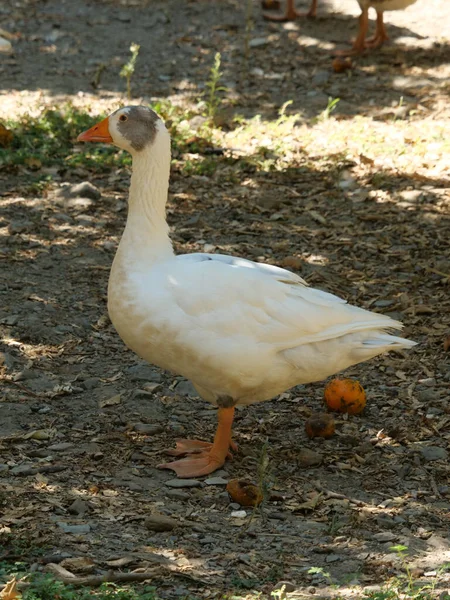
[0,0,450,598]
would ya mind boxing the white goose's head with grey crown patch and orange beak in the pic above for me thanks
[77,106,168,156]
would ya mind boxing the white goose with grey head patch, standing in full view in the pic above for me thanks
[78,106,415,477]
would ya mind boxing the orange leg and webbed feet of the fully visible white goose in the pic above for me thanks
[158,406,236,478]
